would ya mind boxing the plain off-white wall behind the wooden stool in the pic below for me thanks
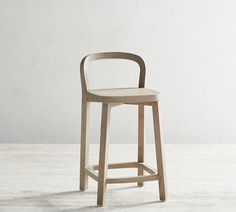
[0,0,236,143]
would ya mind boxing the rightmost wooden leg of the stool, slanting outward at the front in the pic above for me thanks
[152,102,166,201]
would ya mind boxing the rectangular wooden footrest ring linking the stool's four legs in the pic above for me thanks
[85,162,159,184]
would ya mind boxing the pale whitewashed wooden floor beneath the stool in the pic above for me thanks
[0,144,236,212]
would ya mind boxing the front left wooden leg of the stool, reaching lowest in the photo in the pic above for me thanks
[97,103,111,206]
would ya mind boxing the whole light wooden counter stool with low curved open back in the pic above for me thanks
[80,52,166,206]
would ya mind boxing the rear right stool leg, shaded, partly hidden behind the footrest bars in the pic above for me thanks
[138,105,144,186]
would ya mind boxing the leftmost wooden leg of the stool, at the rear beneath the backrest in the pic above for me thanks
[80,99,89,191]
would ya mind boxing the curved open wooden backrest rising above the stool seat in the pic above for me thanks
[80,52,146,94]
